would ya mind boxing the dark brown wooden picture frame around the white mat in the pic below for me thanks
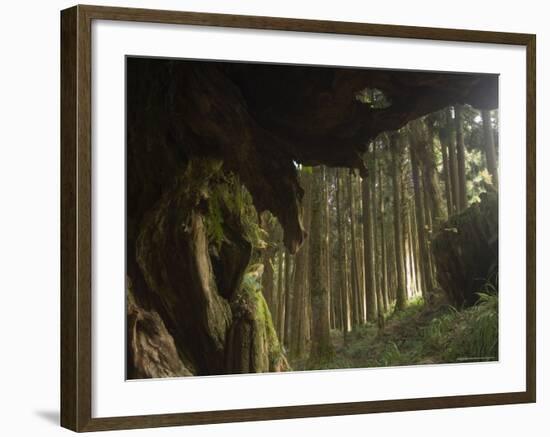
[61,5,536,432]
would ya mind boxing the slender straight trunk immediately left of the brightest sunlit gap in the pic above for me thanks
[390,133,407,310]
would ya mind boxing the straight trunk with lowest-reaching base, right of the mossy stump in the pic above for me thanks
[309,167,332,367]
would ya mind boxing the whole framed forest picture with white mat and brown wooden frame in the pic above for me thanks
[61,6,536,431]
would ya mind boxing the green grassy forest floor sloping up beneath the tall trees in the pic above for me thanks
[292,294,498,370]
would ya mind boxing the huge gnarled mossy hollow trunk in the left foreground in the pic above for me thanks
[133,160,286,376]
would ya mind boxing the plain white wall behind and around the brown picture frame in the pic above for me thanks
[0,0,550,437]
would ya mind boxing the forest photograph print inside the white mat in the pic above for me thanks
[125,56,499,379]
